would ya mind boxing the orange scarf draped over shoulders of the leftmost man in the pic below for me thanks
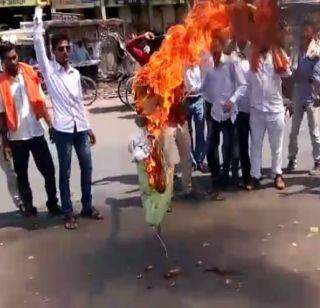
[0,62,45,132]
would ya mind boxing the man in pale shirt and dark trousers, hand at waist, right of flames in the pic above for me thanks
[201,37,247,188]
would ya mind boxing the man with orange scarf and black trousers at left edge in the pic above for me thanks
[0,42,61,216]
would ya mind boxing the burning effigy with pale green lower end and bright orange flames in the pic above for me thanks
[129,1,229,226]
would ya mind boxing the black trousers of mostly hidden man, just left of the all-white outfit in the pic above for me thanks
[236,112,251,182]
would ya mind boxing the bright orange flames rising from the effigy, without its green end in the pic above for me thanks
[134,1,229,192]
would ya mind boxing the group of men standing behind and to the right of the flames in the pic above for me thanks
[127,24,320,197]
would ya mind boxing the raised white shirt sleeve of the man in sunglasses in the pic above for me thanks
[33,6,51,76]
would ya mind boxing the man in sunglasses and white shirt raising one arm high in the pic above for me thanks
[34,4,103,230]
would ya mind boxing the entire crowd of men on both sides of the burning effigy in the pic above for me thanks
[0,1,320,229]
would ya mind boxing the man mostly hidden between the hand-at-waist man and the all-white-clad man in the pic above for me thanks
[231,40,252,190]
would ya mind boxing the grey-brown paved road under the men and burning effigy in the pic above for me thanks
[0,100,320,308]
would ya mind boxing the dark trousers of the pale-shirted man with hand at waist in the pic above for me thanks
[207,119,239,182]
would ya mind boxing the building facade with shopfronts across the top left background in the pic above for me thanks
[0,0,186,32]
